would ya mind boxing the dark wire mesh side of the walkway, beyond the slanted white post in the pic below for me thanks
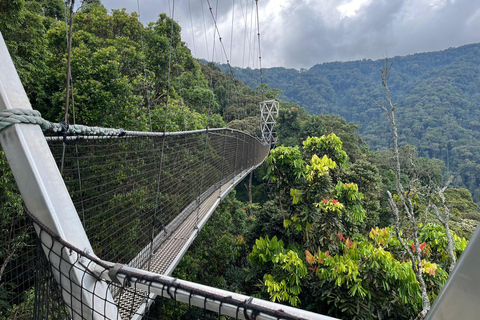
[45,129,269,268]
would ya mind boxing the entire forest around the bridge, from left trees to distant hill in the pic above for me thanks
[0,0,480,319]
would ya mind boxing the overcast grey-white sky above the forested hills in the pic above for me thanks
[102,0,480,69]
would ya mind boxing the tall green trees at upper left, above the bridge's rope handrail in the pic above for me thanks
[0,0,228,131]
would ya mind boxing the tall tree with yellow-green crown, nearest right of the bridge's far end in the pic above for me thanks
[249,134,365,305]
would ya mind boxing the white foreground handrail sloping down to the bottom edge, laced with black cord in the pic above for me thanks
[25,208,330,320]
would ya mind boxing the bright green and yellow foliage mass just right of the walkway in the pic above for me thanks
[176,128,468,319]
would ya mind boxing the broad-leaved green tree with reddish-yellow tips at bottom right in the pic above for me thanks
[306,227,448,319]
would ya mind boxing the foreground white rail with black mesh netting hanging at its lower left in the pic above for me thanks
[25,205,332,320]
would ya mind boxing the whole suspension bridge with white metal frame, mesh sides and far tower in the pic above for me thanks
[0,3,480,320]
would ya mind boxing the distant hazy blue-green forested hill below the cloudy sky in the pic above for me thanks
[218,44,480,203]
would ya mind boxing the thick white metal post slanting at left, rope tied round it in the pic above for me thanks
[0,33,120,319]
